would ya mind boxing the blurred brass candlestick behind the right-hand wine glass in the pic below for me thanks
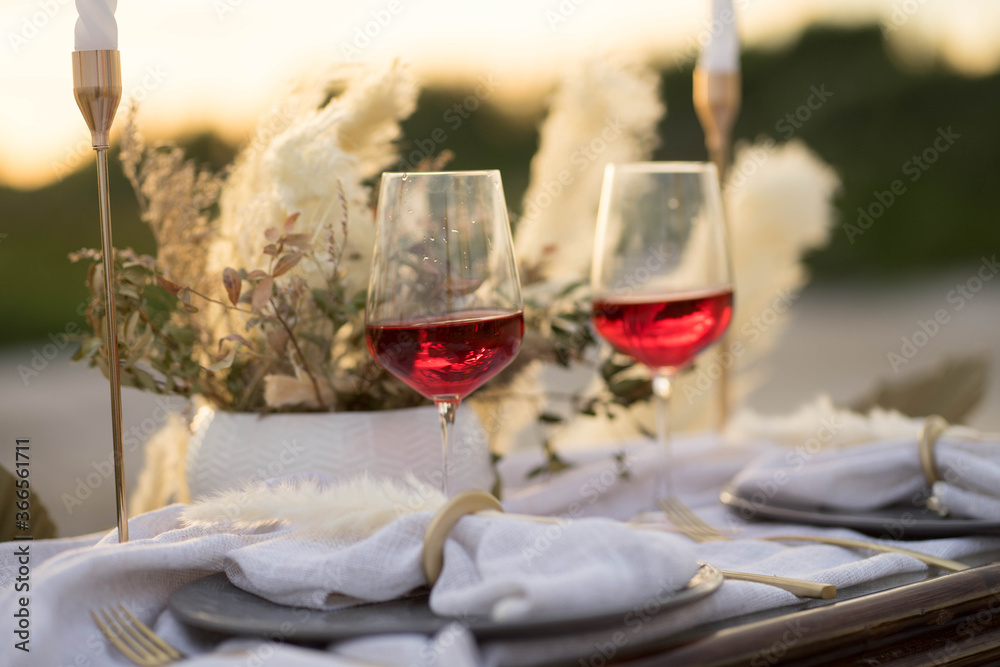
[694,67,741,430]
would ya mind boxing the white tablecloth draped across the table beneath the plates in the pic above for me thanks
[0,436,1000,667]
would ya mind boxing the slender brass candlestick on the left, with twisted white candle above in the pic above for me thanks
[73,50,128,543]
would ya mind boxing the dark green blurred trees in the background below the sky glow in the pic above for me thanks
[0,27,1000,344]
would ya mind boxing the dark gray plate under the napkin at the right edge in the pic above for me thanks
[719,487,1000,540]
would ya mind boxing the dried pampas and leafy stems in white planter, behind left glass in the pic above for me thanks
[72,63,594,412]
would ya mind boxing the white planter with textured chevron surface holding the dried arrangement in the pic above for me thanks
[185,405,492,500]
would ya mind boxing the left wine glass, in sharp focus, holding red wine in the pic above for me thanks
[365,170,524,496]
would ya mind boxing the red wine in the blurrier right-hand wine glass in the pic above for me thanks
[593,287,733,369]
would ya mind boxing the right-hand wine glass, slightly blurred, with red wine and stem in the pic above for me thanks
[591,162,733,507]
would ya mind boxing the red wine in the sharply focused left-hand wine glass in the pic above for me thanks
[365,311,524,399]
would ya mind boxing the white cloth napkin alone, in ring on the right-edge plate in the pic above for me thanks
[732,434,1000,520]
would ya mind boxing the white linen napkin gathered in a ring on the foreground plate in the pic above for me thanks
[204,479,698,620]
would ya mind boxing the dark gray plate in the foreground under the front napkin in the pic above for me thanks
[169,564,722,642]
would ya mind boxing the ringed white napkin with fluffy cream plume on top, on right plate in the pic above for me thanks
[726,396,1000,520]
